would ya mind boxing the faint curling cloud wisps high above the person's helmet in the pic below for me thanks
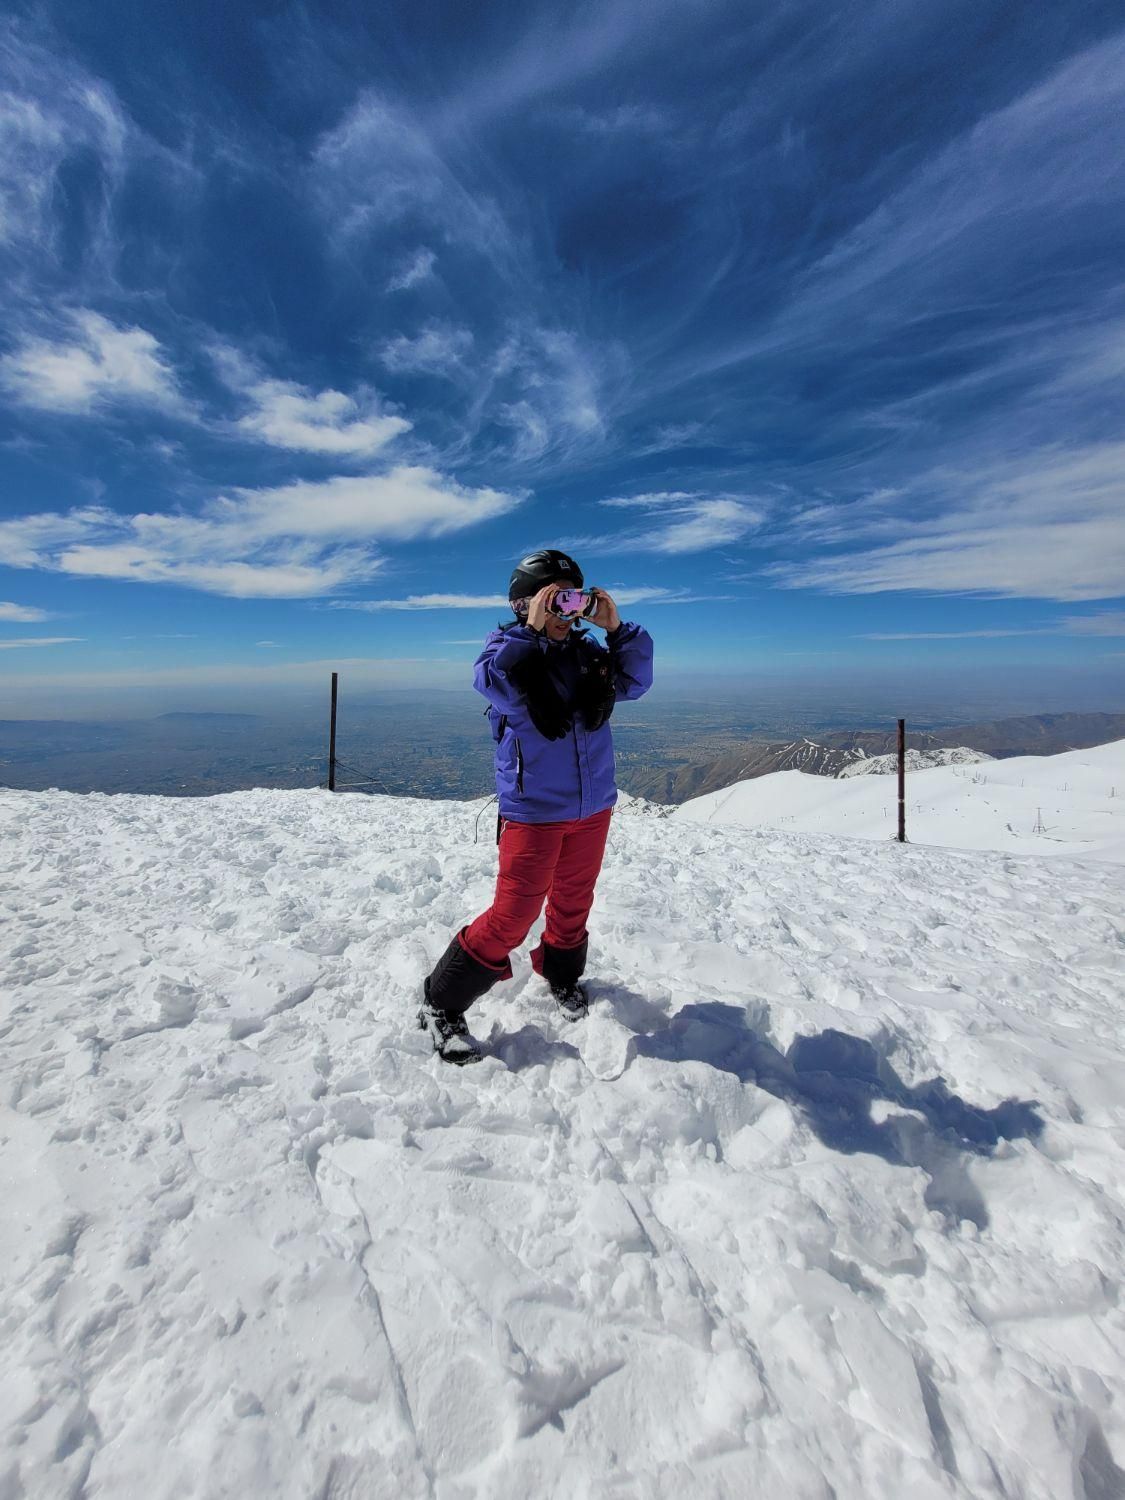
[311,92,627,468]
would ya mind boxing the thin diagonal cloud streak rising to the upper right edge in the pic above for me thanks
[690,33,1125,380]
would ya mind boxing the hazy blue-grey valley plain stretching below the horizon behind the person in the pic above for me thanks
[0,692,1125,804]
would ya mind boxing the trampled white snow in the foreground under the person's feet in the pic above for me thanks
[0,780,1125,1500]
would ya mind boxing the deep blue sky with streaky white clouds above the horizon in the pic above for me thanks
[0,0,1125,717]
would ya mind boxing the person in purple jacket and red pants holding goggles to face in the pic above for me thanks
[419,548,653,1064]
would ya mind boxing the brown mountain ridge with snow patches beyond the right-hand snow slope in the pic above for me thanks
[629,714,1125,804]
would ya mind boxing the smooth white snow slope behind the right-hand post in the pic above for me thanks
[672,740,1125,863]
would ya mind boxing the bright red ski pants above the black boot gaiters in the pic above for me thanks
[459,807,612,978]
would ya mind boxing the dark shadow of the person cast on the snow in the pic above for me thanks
[630,1002,1043,1229]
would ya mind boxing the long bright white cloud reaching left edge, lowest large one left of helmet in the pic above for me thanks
[0,467,519,599]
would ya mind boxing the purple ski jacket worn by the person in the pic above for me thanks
[473,623,653,824]
